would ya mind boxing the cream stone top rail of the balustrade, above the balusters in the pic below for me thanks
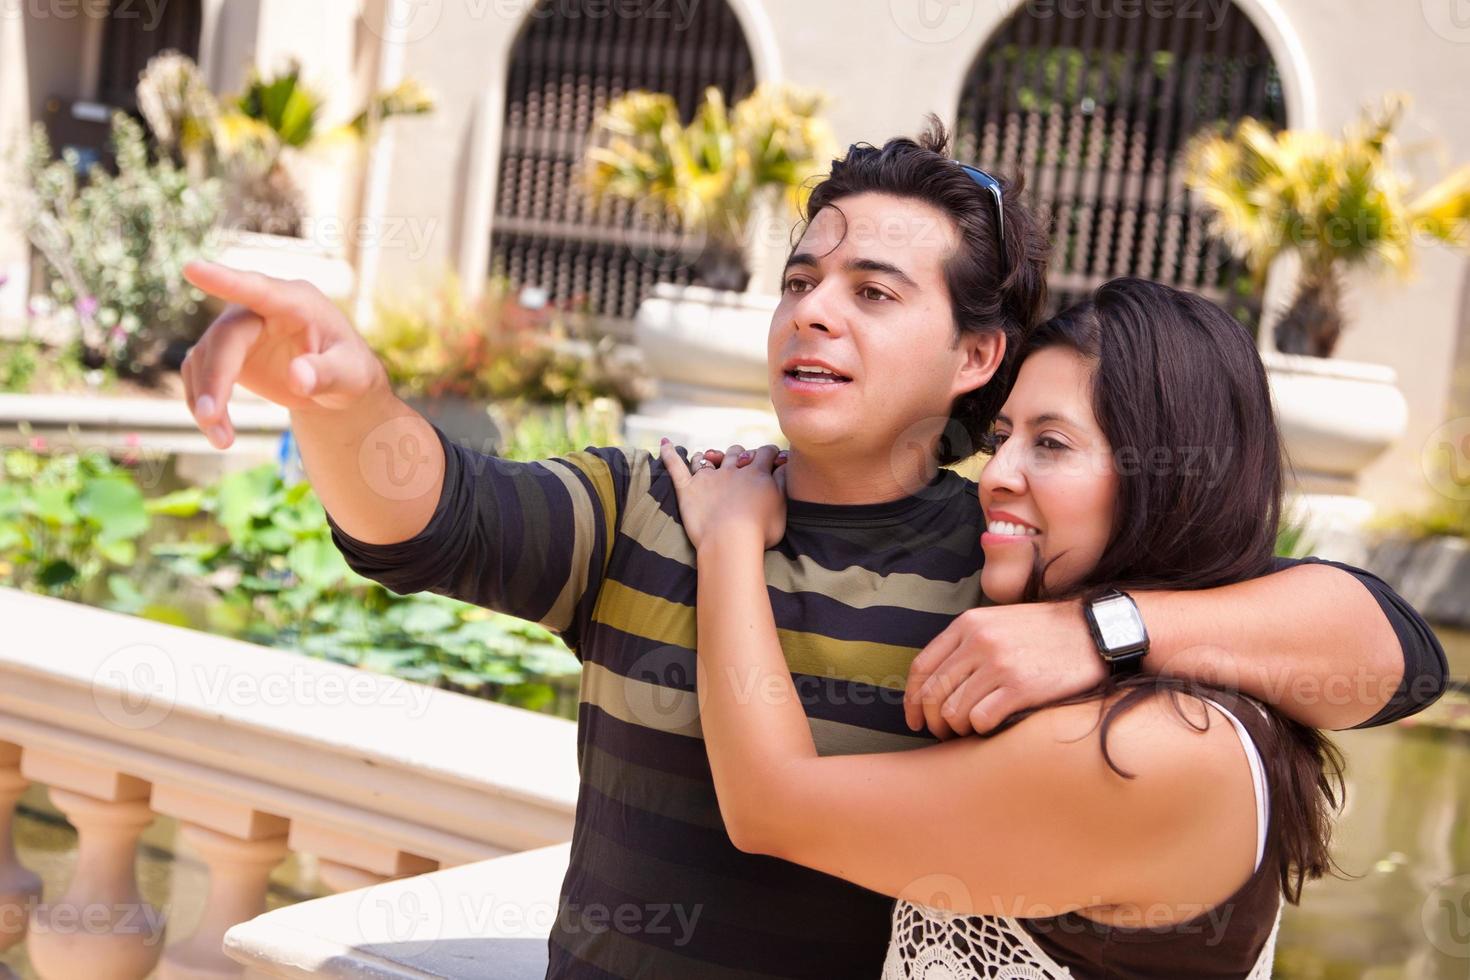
[0,588,578,865]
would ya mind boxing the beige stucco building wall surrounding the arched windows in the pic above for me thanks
[0,0,1470,508]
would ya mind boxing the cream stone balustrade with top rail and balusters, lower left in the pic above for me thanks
[0,588,576,980]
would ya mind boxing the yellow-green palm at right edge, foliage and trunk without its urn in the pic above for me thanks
[1186,97,1470,357]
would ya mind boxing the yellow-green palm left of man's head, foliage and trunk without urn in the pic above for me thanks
[582,85,833,289]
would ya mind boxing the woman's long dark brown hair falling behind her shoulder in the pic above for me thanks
[1001,279,1342,902]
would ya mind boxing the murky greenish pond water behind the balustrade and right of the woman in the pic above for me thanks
[0,630,1470,980]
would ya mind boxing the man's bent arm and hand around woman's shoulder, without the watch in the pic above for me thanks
[904,558,1446,738]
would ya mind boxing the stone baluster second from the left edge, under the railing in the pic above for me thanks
[21,749,163,980]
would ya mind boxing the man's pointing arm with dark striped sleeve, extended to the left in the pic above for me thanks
[184,263,631,648]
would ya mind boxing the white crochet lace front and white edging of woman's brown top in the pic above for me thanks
[882,701,1280,980]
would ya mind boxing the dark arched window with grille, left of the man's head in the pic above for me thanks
[491,0,756,331]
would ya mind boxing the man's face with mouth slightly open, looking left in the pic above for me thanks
[766,192,1004,470]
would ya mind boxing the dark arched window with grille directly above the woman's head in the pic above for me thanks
[956,0,1286,322]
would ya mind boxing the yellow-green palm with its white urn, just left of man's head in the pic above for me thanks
[581,85,833,445]
